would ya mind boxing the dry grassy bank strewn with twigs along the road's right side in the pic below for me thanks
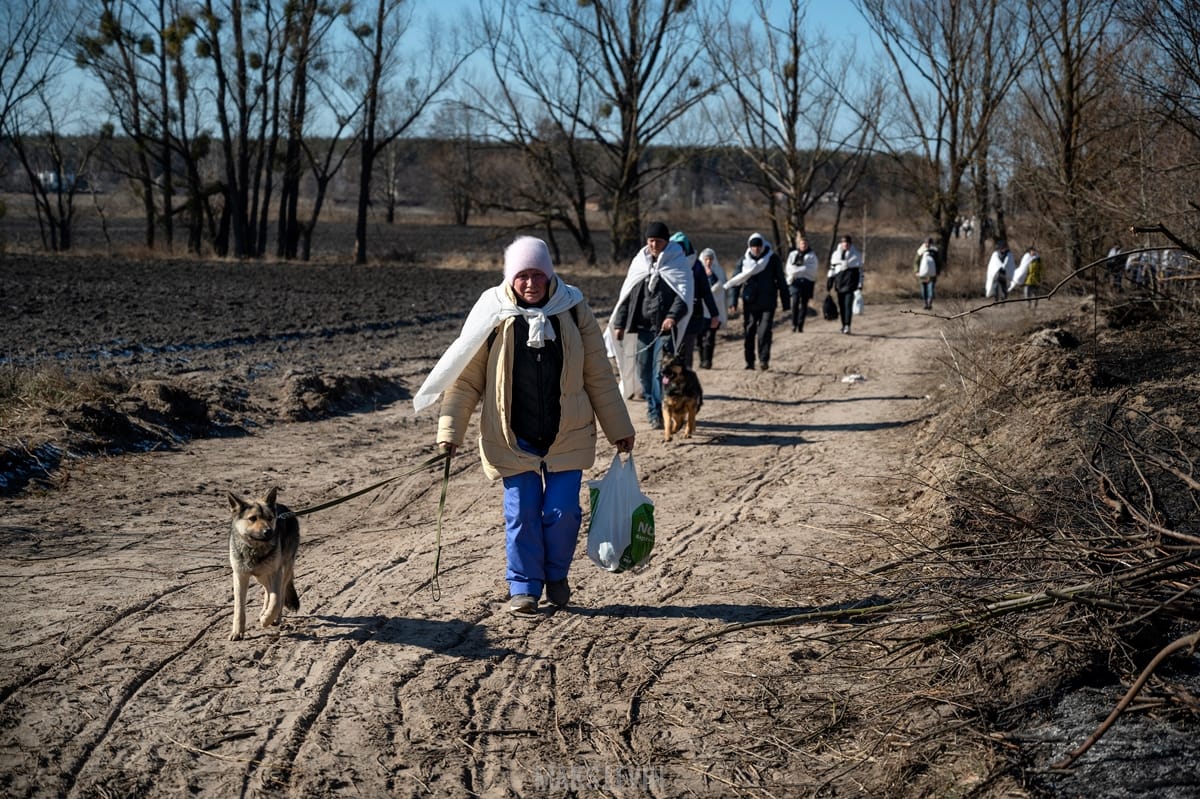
[681,271,1200,797]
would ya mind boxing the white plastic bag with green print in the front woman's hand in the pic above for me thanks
[588,453,654,572]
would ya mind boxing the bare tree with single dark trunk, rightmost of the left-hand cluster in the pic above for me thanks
[350,0,469,264]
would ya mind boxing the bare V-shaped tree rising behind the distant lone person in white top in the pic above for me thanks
[854,0,1033,267]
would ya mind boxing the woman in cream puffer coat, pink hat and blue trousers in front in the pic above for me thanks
[413,236,635,615]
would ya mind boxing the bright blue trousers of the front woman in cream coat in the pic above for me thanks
[504,469,583,596]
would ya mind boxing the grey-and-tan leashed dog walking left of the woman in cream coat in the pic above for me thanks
[229,488,300,641]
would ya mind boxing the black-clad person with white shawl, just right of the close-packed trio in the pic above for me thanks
[725,233,791,371]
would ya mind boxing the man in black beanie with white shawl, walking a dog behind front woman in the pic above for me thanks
[605,222,696,427]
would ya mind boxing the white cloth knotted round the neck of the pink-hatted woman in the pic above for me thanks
[413,276,583,413]
